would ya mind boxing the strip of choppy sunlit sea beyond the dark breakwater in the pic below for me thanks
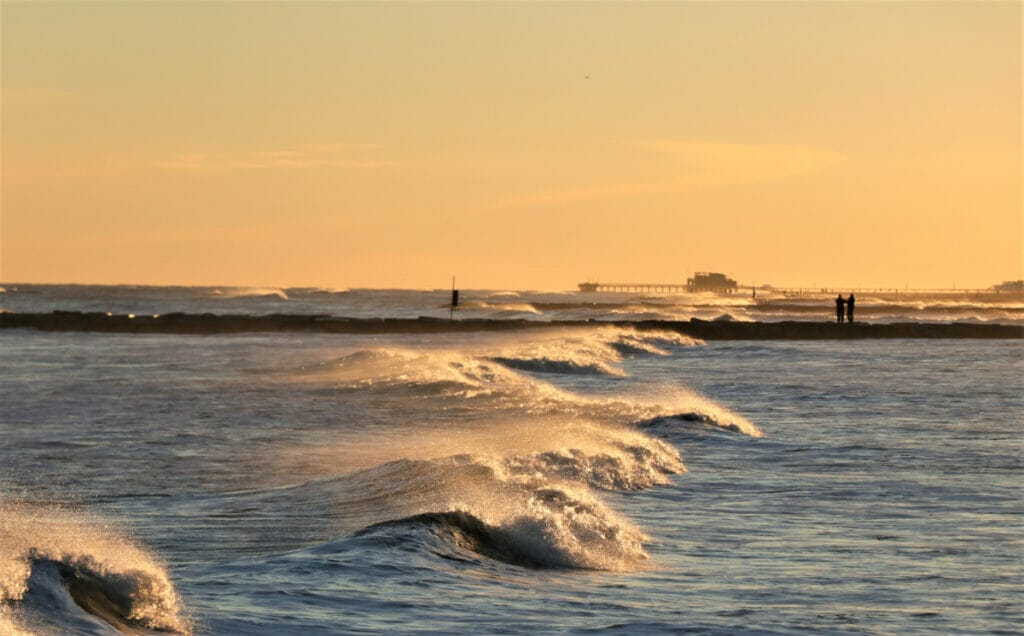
[0,283,1024,325]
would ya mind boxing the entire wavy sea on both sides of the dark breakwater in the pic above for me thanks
[0,284,1024,634]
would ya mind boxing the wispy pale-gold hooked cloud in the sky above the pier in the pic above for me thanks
[497,140,844,208]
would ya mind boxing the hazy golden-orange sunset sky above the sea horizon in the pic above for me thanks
[0,0,1024,290]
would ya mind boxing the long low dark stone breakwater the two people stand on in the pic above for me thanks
[0,311,1024,340]
